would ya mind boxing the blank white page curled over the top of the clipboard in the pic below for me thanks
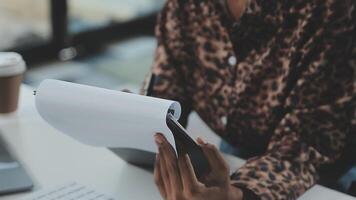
[36,80,181,152]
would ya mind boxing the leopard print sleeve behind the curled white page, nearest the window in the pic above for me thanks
[152,1,192,126]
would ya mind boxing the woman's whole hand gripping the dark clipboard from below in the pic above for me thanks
[154,134,242,200]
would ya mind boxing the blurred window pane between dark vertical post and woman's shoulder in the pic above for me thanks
[68,0,164,33]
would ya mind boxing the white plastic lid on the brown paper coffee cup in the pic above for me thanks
[0,52,26,77]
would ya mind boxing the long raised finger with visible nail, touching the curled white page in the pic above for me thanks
[155,134,183,192]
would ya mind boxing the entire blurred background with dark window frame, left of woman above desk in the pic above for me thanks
[0,0,164,92]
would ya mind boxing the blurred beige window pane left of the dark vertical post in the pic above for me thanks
[0,0,51,50]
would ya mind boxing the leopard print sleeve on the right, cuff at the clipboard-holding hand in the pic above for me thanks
[231,4,356,200]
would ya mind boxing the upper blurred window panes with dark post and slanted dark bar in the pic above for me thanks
[0,0,164,68]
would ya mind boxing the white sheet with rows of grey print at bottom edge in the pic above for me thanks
[28,182,116,200]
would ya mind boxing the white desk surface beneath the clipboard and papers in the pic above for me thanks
[0,85,355,200]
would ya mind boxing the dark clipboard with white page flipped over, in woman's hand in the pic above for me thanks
[35,79,210,179]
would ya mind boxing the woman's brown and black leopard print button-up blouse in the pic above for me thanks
[147,0,356,200]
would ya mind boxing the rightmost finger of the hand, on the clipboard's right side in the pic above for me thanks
[197,138,229,181]
